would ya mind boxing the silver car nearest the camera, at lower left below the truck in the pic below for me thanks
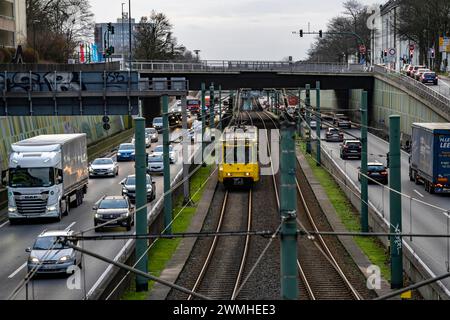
[26,230,82,274]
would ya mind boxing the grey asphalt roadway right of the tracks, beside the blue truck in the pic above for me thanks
[313,129,450,289]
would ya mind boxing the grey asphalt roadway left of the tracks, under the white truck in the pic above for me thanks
[0,129,199,300]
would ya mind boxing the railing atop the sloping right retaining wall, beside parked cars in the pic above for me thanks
[374,65,450,119]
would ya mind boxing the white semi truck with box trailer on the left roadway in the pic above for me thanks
[3,133,89,223]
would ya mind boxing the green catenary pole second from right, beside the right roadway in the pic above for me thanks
[361,91,369,232]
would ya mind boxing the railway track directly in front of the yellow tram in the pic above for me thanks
[187,190,252,300]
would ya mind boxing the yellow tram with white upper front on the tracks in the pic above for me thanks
[219,126,259,187]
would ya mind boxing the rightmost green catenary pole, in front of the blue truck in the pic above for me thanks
[389,115,403,289]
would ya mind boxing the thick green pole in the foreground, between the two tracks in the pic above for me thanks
[280,121,298,300]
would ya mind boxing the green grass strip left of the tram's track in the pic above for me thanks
[122,166,212,300]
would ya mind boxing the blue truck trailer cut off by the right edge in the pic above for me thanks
[409,123,450,194]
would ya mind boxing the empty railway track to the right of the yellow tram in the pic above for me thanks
[257,111,361,300]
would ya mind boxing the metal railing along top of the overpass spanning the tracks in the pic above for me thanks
[132,60,369,73]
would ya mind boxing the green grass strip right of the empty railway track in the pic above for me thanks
[300,143,391,279]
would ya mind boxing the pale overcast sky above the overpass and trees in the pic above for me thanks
[90,0,376,60]
